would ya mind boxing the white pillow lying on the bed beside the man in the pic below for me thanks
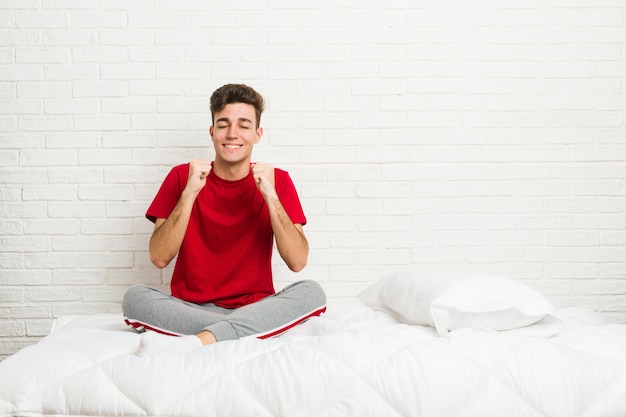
[358,271,554,336]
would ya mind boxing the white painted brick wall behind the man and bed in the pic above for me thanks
[0,0,626,357]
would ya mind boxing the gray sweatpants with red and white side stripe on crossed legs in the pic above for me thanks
[122,280,326,341]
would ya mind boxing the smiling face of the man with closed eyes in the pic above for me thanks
[209,103,263,164]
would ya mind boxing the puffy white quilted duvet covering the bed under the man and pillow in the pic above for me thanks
[0,304,626,417]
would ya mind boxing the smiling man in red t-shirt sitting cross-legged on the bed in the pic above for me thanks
[122,84,326,355]
